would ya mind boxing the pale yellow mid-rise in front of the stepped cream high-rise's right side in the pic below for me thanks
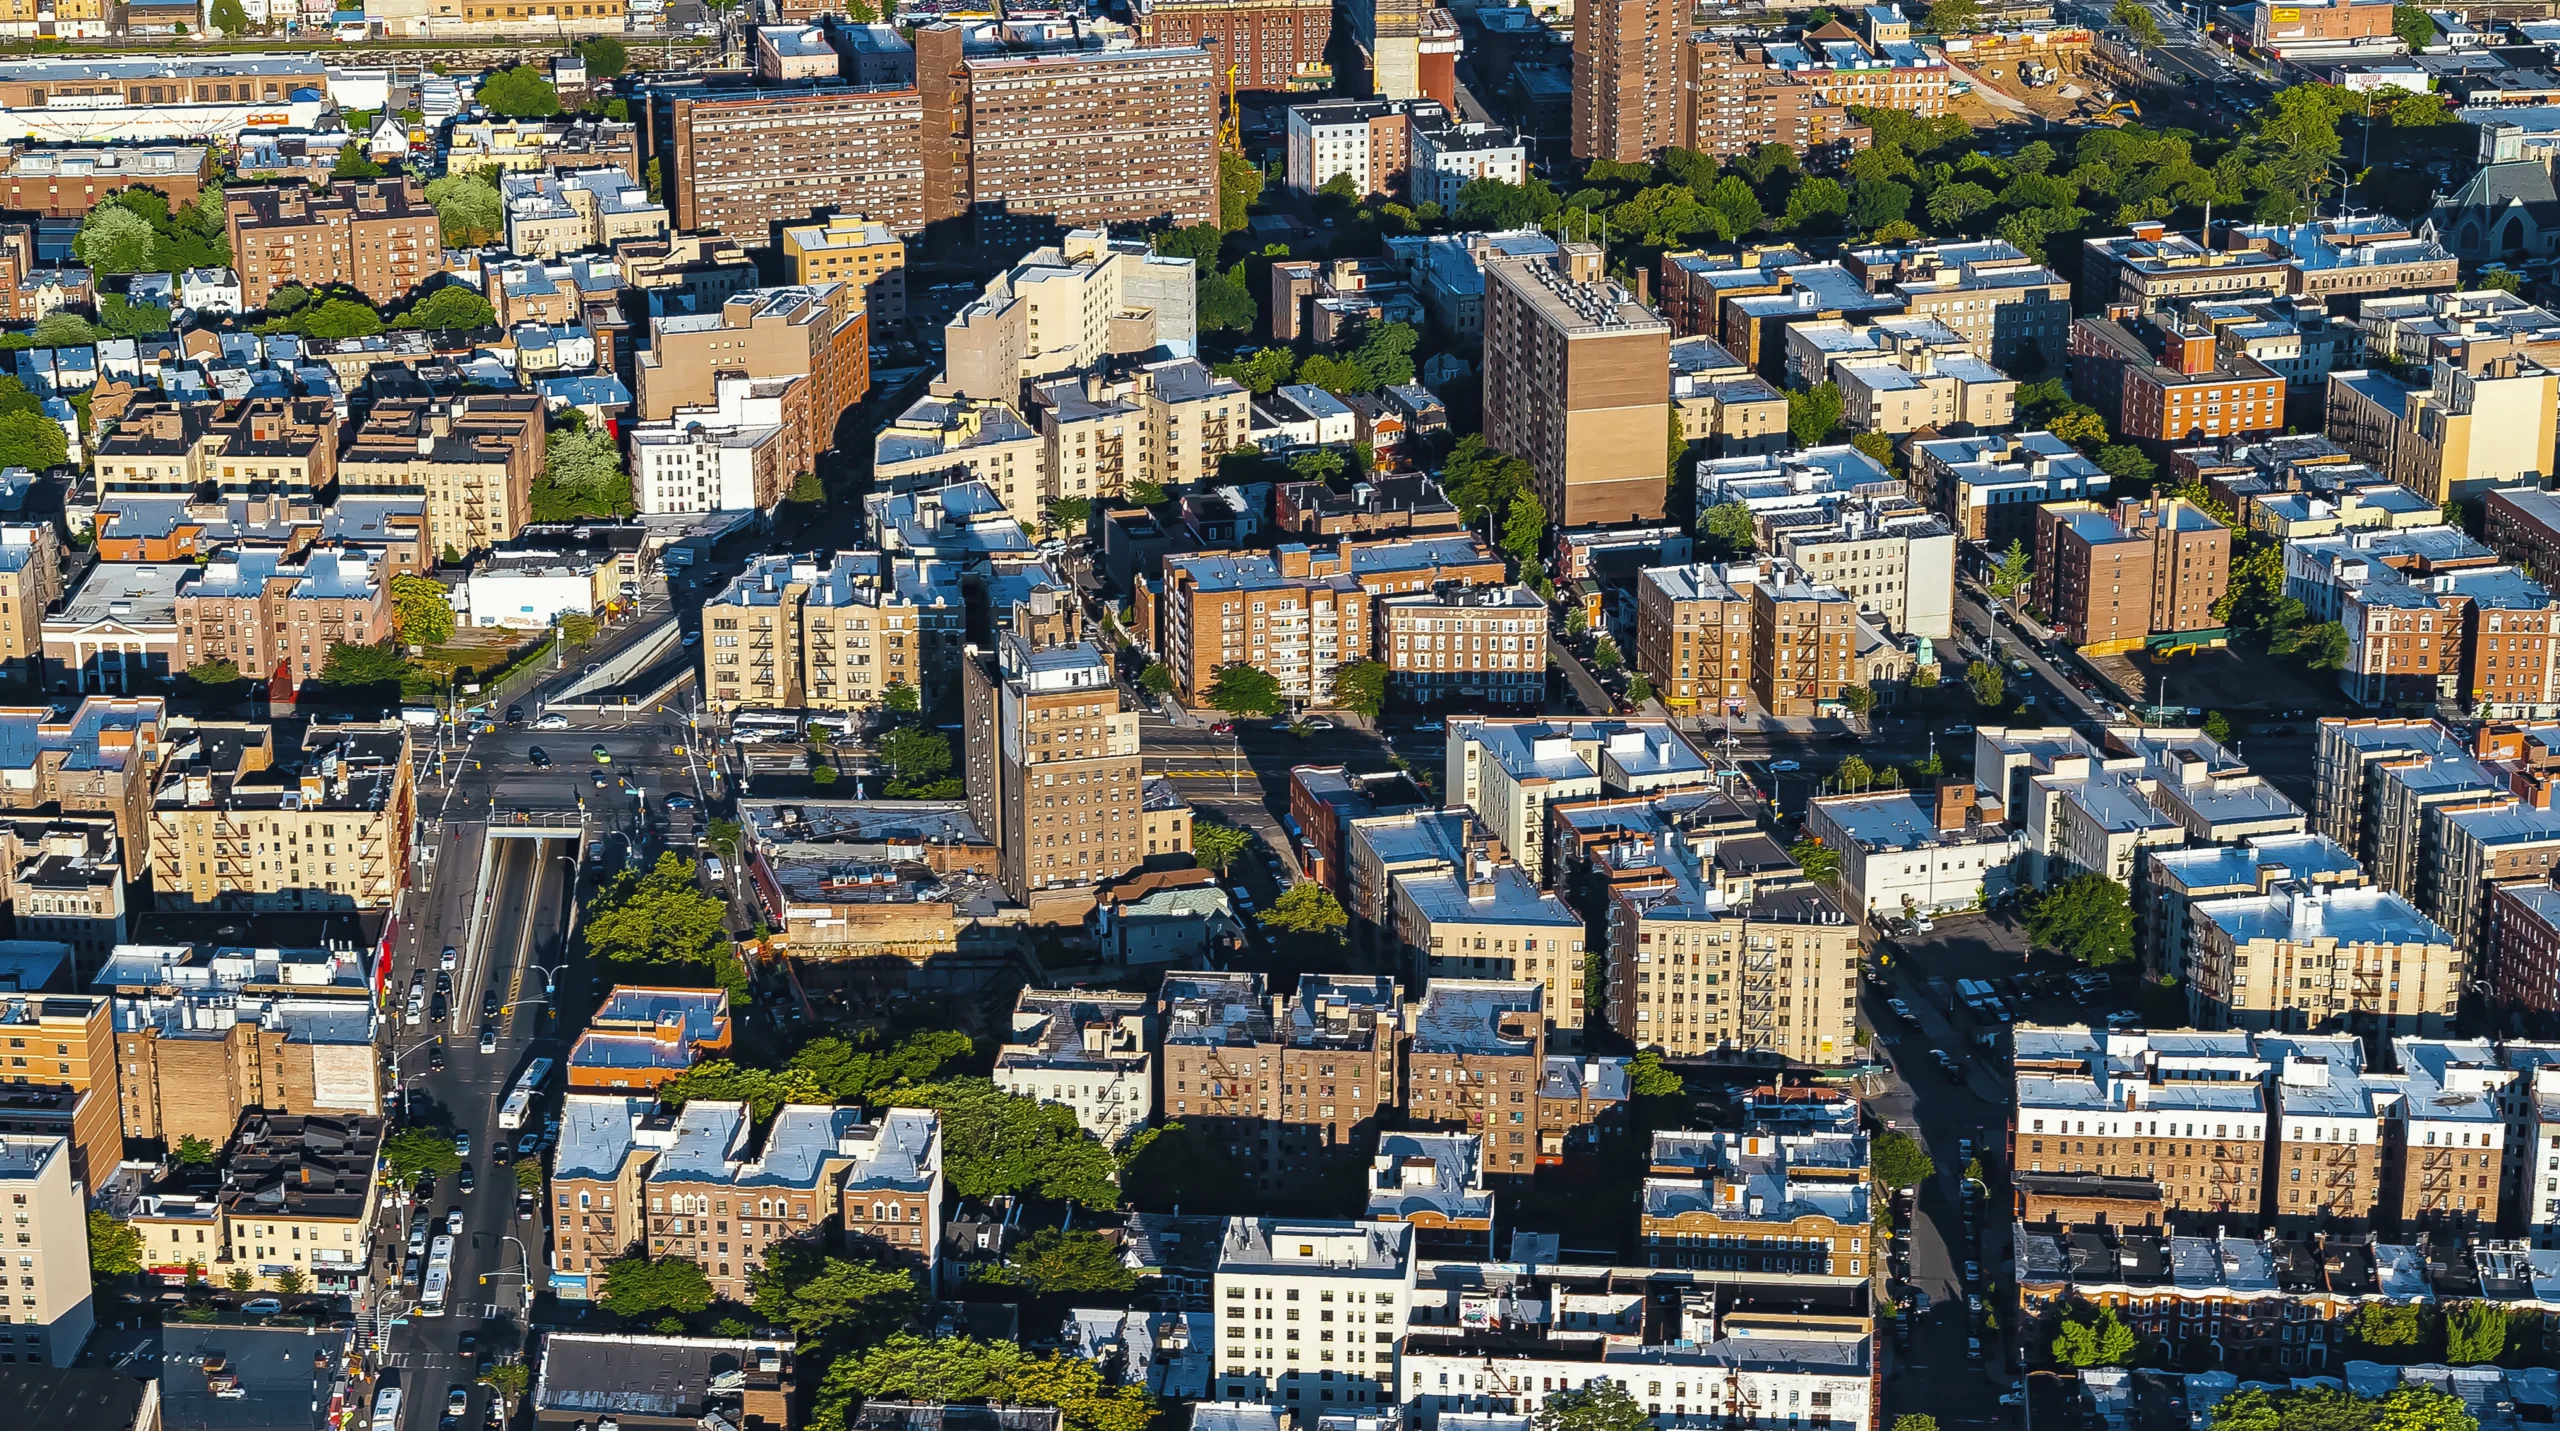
[1029,358,1252,509]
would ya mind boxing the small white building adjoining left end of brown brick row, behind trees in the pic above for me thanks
[996,988,1155,1147]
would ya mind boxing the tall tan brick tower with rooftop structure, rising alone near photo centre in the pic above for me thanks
[960,632,1147,904]
